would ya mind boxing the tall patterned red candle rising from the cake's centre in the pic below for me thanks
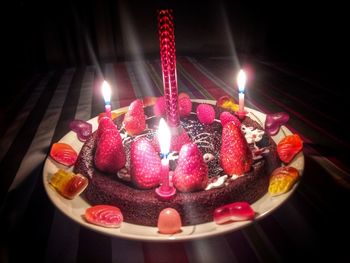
[158,9,180,127]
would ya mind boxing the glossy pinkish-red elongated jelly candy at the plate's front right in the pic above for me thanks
[214,202,255,224]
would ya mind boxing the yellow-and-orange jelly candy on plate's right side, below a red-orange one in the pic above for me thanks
[268,166,299,196]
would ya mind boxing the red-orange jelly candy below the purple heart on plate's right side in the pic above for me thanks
[277,134,303,163]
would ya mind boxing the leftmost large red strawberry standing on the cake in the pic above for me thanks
[95,129,126,173]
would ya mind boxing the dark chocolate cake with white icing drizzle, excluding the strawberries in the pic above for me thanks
[74,103,281,226]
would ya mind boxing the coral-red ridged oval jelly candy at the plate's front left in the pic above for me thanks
[84,205,123,227]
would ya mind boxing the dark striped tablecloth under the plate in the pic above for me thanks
[0,57,350,262]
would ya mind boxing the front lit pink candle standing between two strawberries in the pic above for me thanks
[156,118,176,199]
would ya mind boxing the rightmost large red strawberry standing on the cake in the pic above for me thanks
[220,122,253,175]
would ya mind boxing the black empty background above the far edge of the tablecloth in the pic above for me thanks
[0,0,347,112]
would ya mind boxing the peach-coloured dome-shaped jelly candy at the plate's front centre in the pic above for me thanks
[157,208,181,234]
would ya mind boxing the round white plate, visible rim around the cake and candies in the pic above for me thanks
[43,100,304,241]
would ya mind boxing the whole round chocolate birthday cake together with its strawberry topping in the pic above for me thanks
[74,100,281,226]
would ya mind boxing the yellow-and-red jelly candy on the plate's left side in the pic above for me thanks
[49,169,88,199]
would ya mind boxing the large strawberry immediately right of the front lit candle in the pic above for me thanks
[173,143,208,192]
